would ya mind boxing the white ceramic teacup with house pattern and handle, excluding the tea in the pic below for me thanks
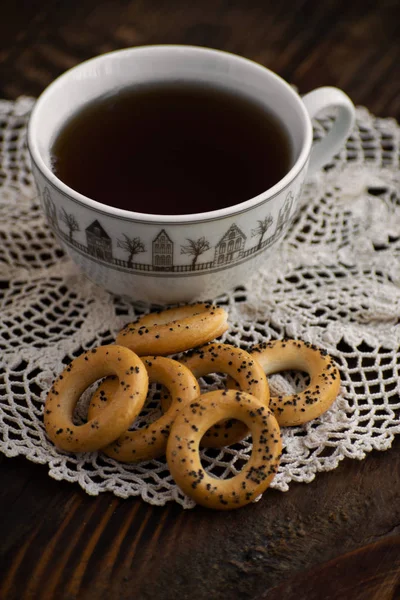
[28,46,354,304]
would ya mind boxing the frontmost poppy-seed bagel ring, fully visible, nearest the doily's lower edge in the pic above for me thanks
[167,390,282,510]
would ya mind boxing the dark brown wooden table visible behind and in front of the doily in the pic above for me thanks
[0,0,400,600]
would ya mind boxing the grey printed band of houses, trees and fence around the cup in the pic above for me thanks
[41,186,300,277]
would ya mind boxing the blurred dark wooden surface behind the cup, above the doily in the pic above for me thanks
[0,0,400,118]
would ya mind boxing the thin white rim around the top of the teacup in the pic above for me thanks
[27,44,312,224]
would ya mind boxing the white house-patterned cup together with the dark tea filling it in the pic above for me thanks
[28,45,354,304]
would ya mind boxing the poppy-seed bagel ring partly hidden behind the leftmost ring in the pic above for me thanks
[88,356,200,462]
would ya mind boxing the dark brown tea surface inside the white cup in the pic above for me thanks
[52,82,291,215]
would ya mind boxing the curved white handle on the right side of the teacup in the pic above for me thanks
[302,87,355,175]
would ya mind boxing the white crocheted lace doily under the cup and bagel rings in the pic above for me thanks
[0,98,400,508]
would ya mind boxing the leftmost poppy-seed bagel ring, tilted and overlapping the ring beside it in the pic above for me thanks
[44,345,148,452]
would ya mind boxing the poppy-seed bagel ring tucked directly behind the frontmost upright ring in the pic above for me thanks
[175,343,269,448]
